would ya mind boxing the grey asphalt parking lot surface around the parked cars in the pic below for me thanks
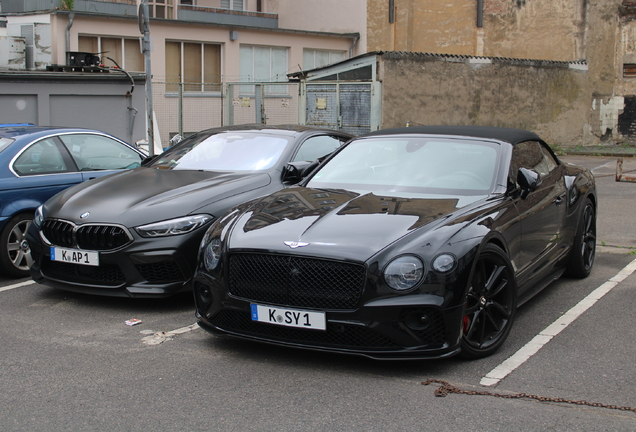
[0,155,636,432]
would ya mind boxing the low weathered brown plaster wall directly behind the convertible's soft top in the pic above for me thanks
[380,53,590,146]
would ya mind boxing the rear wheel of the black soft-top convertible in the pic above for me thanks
[567,198,596,279]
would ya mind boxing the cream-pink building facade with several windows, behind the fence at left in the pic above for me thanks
[0,0,366,146]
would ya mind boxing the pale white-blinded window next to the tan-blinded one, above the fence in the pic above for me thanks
[239,45,288,94]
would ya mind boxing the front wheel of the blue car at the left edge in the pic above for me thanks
[0,213,33,278]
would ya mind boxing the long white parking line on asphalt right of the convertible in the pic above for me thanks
[479,259,636,386]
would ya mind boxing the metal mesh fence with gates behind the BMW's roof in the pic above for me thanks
[152,81,374,148]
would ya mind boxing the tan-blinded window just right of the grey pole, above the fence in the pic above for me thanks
[166,41,221,92]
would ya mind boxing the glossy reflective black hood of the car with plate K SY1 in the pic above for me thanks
[230,187,484,260]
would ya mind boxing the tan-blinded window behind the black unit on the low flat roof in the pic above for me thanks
[77,36,145,72]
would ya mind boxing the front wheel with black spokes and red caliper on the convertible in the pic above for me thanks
[460,244,517,359]
